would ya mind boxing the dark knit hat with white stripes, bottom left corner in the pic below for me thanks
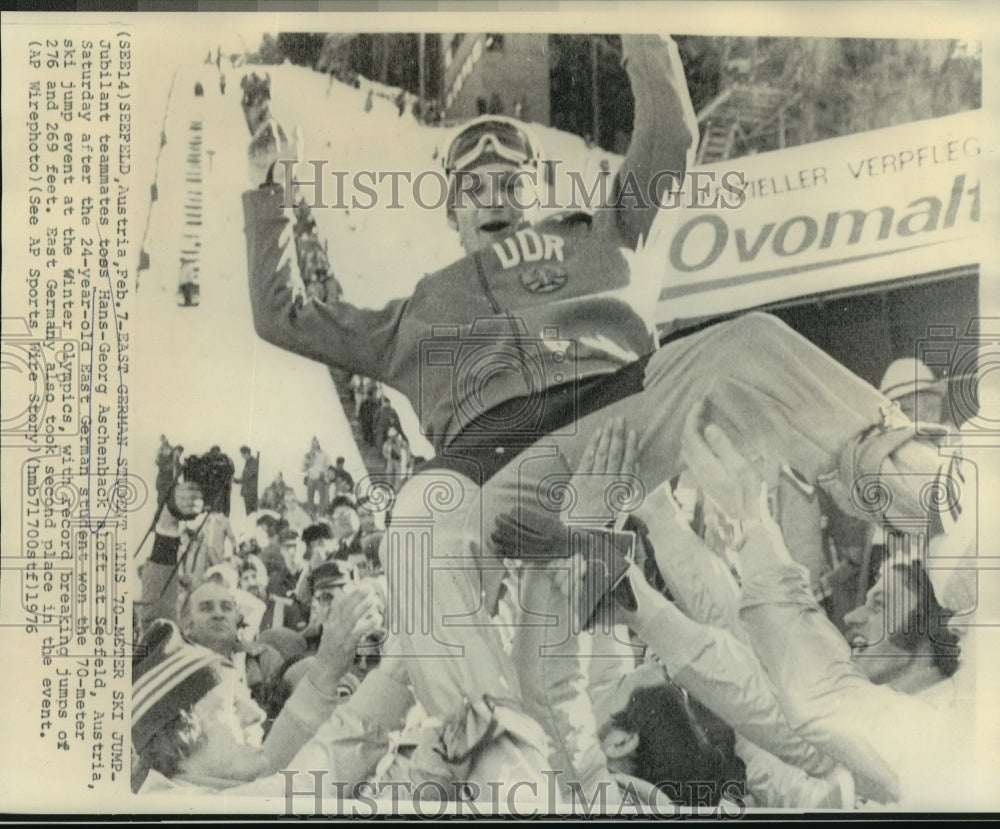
[132,619,224,752]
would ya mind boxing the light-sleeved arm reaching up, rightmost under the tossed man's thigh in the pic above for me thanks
[685,425,936,803]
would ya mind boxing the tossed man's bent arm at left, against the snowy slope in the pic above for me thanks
[243,184,406,380]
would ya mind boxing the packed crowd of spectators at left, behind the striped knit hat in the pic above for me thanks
[133,436,394,790]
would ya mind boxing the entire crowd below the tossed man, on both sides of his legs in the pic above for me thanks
[133,364,973,809]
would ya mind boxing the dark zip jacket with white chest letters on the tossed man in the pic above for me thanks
[243,36,697,448]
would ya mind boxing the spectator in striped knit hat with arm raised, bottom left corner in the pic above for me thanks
[132,594,402,797]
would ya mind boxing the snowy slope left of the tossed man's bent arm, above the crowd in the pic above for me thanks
[132,66,372,552]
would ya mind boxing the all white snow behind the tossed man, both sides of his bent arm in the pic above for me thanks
[130,56,618,552]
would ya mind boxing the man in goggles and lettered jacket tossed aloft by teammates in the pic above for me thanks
[244,35,952,804]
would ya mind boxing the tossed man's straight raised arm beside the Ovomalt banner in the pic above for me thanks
[598,35,698,249]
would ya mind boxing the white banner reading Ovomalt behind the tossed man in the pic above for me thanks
[656,106,981,325]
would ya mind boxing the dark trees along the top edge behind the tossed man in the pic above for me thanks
[251,32,982,157]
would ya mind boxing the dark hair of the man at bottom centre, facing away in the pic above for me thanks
[611,681,746,806]
